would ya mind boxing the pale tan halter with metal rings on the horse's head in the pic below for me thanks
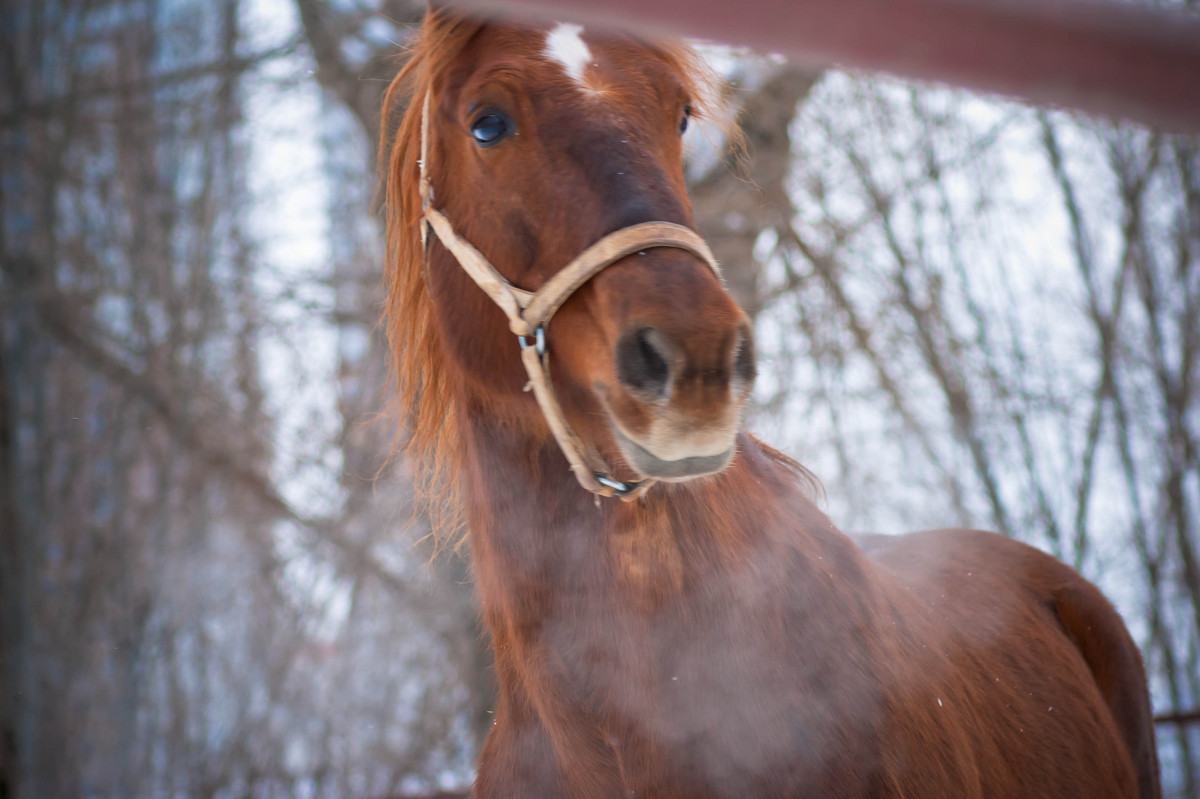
[418,92,721,501]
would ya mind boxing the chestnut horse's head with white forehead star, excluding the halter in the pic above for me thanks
[392,11,755,489]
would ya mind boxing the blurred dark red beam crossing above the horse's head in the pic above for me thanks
[458,0,1200,132]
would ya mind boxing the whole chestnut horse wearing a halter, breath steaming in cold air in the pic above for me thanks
[380,8,1160,799]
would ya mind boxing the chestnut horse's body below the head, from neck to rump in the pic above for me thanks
[472,419,1157,798]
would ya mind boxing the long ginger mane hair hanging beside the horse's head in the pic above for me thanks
[377,8,738,539]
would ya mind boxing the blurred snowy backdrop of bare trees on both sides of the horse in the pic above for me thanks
[0,0,1200,799]
